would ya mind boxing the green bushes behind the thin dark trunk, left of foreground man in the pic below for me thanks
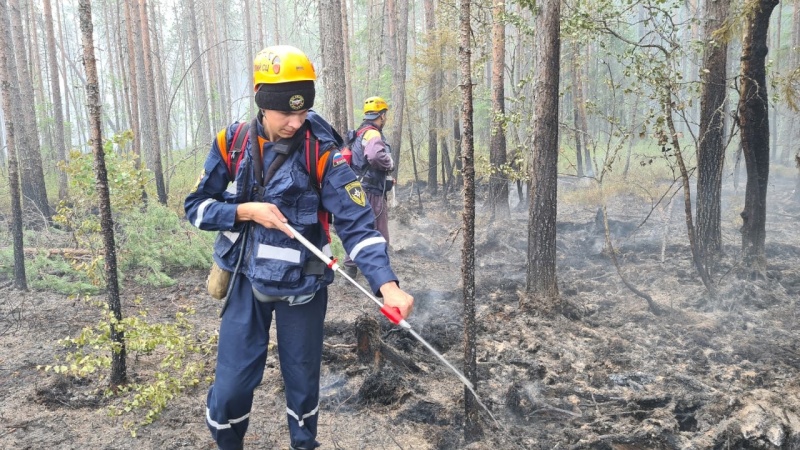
[47,131,213,293]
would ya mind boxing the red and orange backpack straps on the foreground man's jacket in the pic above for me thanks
[217,119,332,242]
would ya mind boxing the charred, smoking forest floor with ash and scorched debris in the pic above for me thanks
[0,173,800,450]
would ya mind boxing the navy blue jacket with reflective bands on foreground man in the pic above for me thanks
[184,111,397,296]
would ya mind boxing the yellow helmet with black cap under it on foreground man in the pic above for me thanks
[253,45,317,112]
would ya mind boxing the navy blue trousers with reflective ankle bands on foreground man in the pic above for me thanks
[211,275,328,450]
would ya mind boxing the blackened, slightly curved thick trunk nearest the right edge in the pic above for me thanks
[739,0,778,278]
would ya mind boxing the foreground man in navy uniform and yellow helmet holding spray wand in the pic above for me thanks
[184,46,414,450]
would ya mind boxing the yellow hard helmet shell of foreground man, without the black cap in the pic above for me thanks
[253,45,317,88]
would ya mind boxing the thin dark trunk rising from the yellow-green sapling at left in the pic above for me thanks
[78,0,127,386]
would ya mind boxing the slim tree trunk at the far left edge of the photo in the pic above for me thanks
[0,0,28,291]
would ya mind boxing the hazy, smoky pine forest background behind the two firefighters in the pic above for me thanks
[0,0,800,446]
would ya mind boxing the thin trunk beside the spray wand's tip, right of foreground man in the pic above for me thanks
[458,0,483,443]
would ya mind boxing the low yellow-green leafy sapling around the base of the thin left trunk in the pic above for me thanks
[38,301,217,436]
